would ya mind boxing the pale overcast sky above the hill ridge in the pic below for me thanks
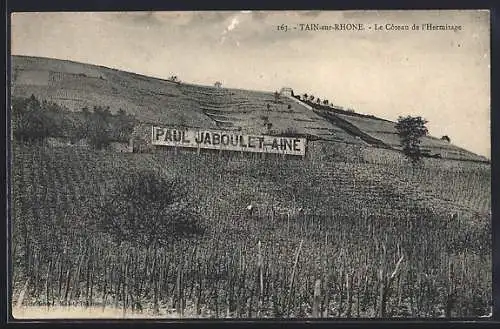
[11,11,490,157]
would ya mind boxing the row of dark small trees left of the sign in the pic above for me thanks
[12,95,137,149]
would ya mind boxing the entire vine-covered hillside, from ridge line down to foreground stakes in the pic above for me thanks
[11,56,492,318]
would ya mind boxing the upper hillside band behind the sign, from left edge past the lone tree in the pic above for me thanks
[12,56,486,161]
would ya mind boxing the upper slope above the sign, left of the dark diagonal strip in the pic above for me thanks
[12,56,359,143]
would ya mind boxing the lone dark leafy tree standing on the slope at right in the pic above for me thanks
[395,116,429,164]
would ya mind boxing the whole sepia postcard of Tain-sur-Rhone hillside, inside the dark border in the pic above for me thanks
[10,10,492,320]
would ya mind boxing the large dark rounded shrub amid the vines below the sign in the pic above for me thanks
[96,170,204,245]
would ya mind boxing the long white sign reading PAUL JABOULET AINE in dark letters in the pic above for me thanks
[151,126,306,155]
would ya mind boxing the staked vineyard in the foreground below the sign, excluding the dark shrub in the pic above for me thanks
[12,142,491,317]
